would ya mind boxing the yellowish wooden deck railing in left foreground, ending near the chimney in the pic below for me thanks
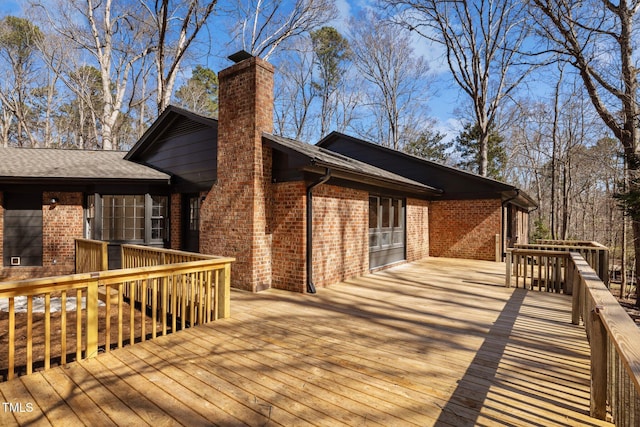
[0,249,234,379]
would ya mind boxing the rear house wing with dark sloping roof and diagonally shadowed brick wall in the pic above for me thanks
[317,132,537,261]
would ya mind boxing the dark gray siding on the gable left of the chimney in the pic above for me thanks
[135,117,218,191]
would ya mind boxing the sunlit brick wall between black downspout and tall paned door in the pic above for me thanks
[313,184,369,287]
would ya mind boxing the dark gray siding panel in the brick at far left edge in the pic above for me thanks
[3,193,42,267]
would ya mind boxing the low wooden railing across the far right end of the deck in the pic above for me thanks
[506,240,609,294]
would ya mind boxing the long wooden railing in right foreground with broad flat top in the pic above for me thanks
[567,252,640,426]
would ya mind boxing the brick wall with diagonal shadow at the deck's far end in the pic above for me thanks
[429,199,502,261]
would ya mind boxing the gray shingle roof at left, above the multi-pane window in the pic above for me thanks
[0,147,170,181]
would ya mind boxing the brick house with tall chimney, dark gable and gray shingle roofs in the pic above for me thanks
[0,51,527,292]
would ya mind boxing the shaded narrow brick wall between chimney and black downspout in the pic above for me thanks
[272,181,307,292]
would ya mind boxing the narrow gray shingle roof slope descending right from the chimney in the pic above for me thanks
[263,133,442,194]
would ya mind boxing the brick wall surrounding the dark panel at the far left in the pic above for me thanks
[0,192,84,280]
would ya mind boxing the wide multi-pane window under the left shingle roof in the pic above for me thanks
[86,194,169,243]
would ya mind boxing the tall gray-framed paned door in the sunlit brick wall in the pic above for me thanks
[369,196,406,268]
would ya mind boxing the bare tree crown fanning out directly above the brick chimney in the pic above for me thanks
[231,0,337,59]
